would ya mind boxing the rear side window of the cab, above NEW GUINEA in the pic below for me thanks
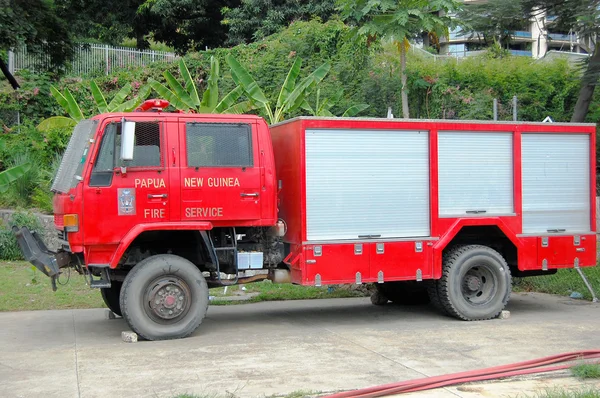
[185,123,254,167]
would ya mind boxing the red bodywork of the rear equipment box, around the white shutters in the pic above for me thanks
[271,118,596,285]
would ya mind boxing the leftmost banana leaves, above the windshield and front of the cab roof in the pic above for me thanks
[37,80,150,131]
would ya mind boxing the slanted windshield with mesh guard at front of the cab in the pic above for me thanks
[52,120,98,193]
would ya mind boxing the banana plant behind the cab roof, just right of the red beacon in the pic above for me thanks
[148,57,254,114]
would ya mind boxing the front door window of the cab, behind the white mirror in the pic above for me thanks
[90,122,163,187]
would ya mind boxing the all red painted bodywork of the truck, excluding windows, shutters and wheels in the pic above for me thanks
[54,112,596,285]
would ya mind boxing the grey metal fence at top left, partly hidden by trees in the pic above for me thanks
[9,43,178,75]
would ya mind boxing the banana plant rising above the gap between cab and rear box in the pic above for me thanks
[226,55,331,124]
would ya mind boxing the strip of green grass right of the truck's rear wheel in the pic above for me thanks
[514,266,600,300]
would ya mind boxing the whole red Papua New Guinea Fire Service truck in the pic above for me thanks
[13,100,596,340]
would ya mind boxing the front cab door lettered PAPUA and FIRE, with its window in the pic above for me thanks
[83,118,171,251]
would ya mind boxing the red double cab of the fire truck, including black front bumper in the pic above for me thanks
[17,100,283,339]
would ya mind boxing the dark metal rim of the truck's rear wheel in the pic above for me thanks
[461,264,498,306]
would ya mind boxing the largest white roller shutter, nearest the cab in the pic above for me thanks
[306,130,430,241]
